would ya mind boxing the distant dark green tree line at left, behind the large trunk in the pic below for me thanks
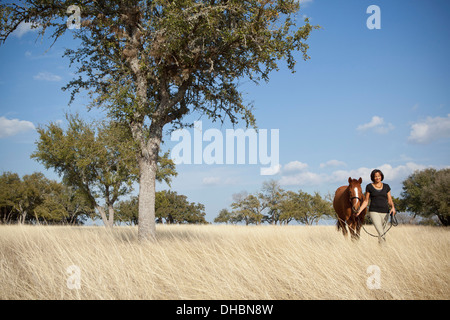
[0,172,207,225]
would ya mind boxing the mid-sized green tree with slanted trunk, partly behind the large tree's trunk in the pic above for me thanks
[31,115,177,225]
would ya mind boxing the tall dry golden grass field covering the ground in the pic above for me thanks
[0,225,450,300]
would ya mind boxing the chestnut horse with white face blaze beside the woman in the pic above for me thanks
[333,177,367,240]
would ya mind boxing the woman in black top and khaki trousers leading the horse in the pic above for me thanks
[356,169,396,243]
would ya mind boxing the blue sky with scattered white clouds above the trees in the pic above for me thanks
[0,0,450,221]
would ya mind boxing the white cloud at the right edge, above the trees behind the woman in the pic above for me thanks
[408,114,450,144]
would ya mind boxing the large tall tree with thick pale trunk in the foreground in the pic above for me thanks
[0,0,318,239]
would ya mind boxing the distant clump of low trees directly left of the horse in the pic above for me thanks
[214,180,334,225]
